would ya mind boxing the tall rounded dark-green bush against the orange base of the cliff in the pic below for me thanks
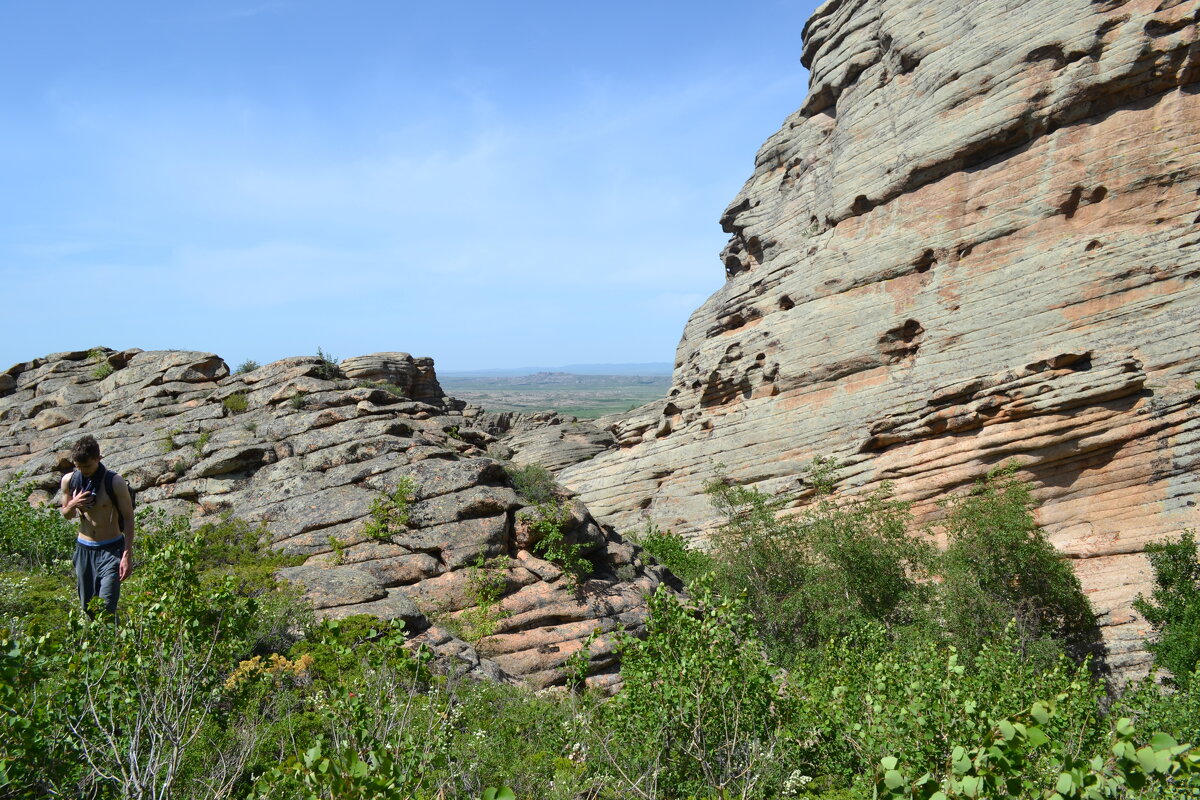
[940,464,1099,658]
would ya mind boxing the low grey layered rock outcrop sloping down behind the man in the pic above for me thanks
[0,348,664,686]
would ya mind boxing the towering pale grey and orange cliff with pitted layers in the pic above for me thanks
[540,0,1200,670]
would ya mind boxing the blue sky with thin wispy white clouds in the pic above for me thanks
[0,0,817,369]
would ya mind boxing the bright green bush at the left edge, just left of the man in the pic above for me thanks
[0,473,74,573]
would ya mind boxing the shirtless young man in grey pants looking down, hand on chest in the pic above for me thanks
[59,437,133,614]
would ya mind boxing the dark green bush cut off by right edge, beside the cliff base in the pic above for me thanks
[1133,530,1200,682]
